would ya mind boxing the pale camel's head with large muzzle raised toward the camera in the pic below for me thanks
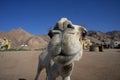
[48,18,87,65]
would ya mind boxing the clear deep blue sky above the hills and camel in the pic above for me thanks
[0,0,120,34]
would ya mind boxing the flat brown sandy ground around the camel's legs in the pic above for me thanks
[0,49,120,80]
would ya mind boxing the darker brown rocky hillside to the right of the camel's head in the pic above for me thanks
[88,31,120,43]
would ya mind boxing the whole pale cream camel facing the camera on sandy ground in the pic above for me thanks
[35,18,87,80]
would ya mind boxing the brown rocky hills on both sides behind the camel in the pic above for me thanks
[0,28,120,49]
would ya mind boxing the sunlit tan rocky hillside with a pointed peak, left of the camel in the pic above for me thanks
[0,28,49,50]
